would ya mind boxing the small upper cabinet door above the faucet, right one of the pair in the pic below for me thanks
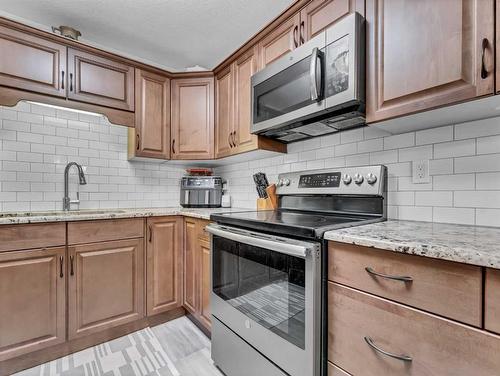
[68,48,134,111]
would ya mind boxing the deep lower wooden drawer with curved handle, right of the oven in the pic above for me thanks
[328,282,500,376]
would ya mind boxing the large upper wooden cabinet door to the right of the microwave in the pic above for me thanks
[366,0,494,122]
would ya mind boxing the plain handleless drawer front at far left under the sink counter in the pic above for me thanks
[0,222,66,252]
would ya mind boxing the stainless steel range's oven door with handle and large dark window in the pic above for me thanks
[207,224,321,376]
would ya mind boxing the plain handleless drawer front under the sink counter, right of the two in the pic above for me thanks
[68,218,144,245]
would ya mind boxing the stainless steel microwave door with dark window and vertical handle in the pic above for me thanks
[252,32,326,133]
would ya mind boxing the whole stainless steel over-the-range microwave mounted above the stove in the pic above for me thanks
[251,13,365,142]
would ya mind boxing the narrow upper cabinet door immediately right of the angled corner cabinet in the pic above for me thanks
[215,65,235,158]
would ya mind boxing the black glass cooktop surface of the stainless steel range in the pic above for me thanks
[210,209,376,238]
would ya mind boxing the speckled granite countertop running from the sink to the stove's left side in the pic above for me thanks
[0,207,251,225]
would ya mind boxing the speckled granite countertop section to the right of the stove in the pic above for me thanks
[324,220,500,269]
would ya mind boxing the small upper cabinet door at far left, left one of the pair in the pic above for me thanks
[0,26,66,97]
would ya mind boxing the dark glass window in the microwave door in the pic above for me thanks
[253,56,314,123]
